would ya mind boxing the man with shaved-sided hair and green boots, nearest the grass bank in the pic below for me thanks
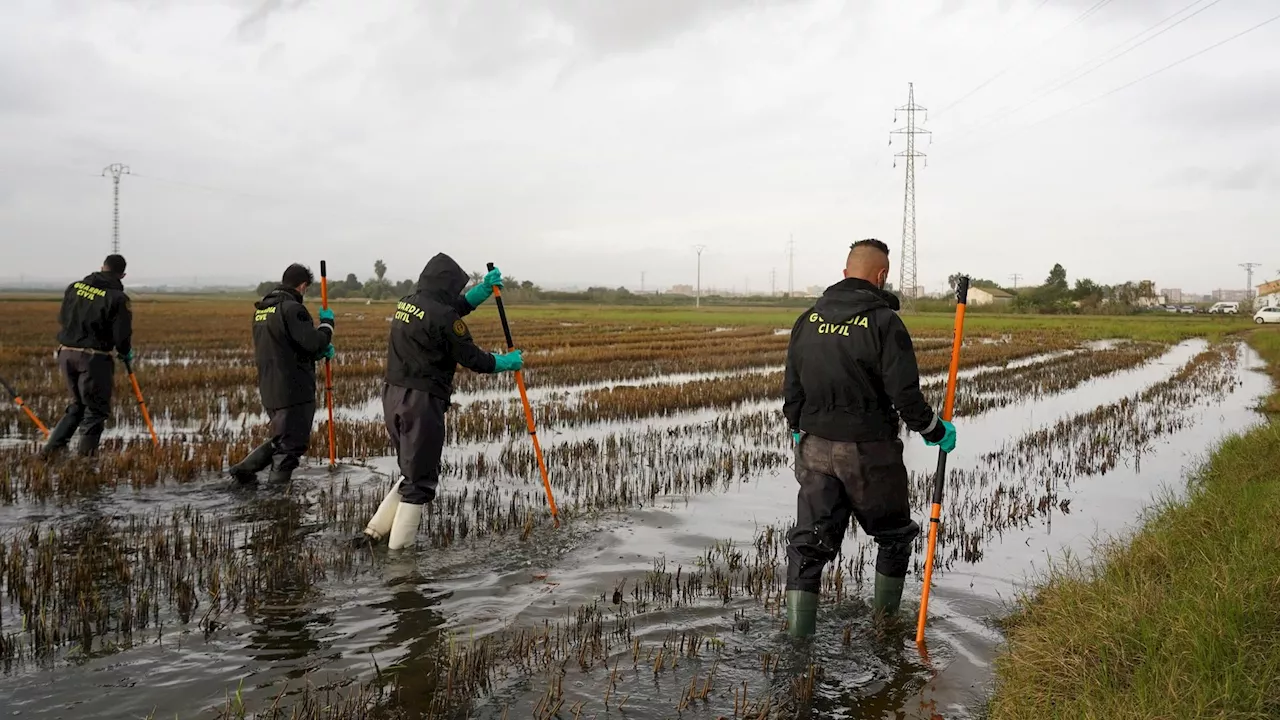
[782,240,955,637]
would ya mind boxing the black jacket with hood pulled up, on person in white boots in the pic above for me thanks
[387,252,494,400]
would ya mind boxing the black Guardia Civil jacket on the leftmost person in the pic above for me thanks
[58,273,133,355]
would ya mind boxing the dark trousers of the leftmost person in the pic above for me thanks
[45,348,115,455]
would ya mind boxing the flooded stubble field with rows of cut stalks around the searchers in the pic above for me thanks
[0,301,1268,720]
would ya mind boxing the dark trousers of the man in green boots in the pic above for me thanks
[787,434,920,592]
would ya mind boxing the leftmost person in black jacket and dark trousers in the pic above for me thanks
[41,255,133,459]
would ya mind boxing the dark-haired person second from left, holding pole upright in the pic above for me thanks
[230,264,334,483]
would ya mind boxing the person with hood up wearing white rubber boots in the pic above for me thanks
[365,252,522,550]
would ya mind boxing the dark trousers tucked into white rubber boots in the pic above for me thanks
[383,384,449,505]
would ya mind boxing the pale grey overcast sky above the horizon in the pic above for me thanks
[0,0,1280,292]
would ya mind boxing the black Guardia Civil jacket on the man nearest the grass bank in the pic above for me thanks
[782,278,945,442]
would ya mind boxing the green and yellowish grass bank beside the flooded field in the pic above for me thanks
[989,329,1280,720]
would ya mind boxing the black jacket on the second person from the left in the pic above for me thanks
[253,286,333,410]
